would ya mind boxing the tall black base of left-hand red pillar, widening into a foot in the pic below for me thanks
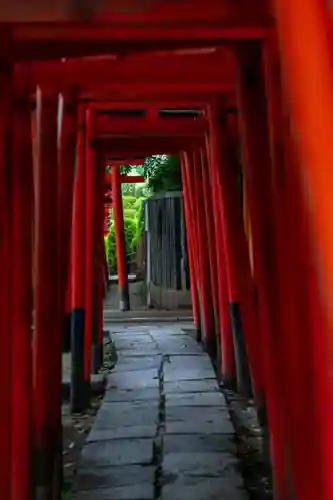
[70,309,91,413]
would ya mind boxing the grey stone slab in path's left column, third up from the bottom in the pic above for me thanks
[80,438,153,468]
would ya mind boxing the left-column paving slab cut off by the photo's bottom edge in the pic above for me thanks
[75,483,154,500]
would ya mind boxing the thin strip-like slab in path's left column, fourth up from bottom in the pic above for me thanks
[87,424,157,443]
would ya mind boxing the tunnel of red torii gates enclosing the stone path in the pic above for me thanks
[0,0,333,500]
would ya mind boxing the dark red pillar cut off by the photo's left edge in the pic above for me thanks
[0,66,13,498]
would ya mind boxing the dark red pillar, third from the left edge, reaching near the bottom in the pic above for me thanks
[34,89,61,497]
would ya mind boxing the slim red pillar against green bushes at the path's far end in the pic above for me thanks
[112,166,130,311]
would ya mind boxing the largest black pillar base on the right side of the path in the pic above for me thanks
[229,302,252,397]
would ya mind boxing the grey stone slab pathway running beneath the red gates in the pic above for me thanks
[74,323,248,500]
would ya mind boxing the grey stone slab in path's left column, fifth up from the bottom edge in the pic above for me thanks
[94,401,158,429]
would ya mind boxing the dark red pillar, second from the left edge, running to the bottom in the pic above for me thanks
[11,97,33,500]
